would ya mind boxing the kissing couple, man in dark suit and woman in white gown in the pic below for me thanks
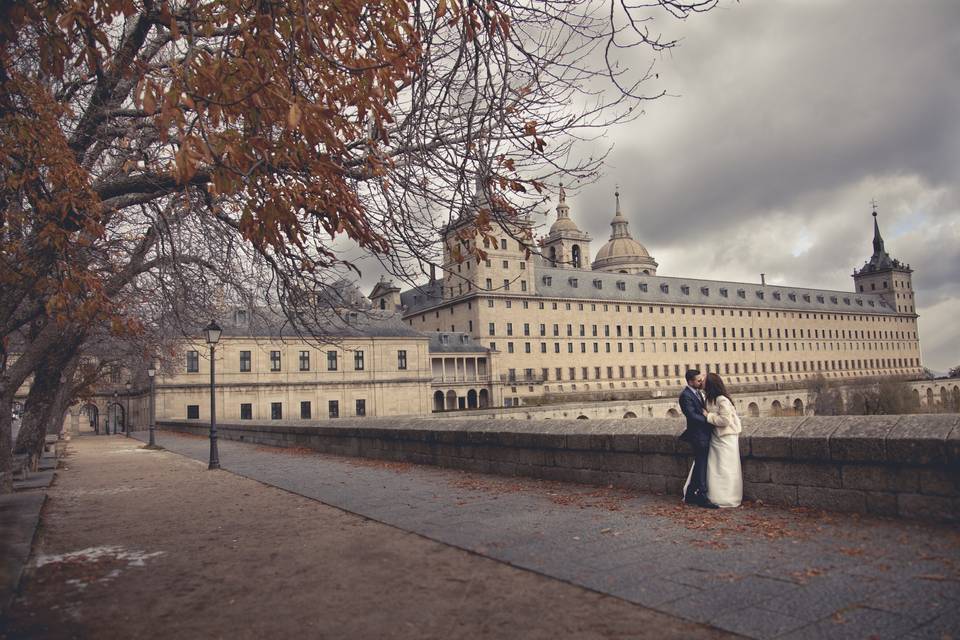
[680,369,743,509]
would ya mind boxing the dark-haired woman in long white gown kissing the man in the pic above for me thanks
[688,373,743,507]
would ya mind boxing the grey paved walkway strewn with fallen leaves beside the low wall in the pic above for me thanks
[138,432,960,640]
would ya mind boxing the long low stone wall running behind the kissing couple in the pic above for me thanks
[160,414,960,522]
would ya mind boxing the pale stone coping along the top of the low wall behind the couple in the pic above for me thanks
[158,414,960,466]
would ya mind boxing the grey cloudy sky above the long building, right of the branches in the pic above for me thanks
[547,0,960,371]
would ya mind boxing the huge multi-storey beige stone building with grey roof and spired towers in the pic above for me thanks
[390,190,922,405]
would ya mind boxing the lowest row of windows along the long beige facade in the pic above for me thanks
[507,358,920,382]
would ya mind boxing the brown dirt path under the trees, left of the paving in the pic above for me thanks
[0,437,736,639]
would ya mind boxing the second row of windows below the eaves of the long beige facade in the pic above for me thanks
[487,322,917,340]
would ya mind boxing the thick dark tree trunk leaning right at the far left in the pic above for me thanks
[14,351,76,471]
